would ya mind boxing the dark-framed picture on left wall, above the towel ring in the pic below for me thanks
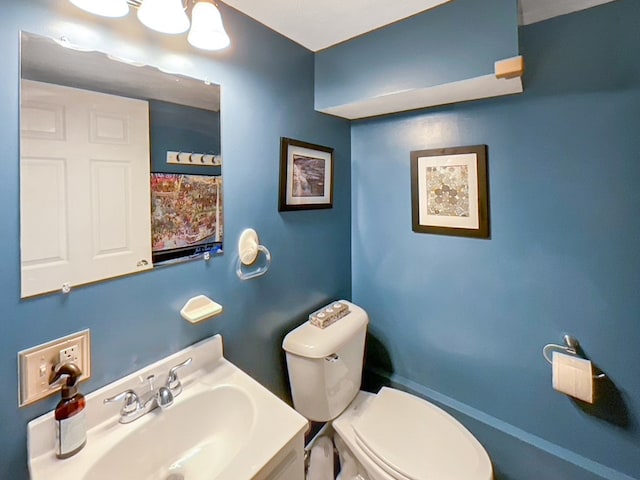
[278,137,333,212]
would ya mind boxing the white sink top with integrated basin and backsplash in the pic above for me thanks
[28,335,307,480]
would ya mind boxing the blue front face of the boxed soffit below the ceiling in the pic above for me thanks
[315,0,518,110]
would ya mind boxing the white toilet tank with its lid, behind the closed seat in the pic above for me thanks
[282,300,369,422]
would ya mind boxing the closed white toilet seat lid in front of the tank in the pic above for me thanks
[351,387,492,480]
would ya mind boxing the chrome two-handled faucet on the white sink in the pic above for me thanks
[103,357,191,423]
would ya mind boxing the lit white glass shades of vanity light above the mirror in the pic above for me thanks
[69,0,231,50]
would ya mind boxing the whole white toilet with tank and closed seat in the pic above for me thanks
[282,300,493,480]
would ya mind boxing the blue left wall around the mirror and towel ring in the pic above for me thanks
[0,0,351,479]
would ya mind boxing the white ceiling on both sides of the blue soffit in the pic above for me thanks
[224,0,613,52]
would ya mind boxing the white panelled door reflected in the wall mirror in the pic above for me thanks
[20,80,152,297]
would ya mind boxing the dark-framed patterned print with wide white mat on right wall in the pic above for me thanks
[411,145,490,238]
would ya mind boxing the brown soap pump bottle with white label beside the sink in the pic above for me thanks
[51,362,87,458]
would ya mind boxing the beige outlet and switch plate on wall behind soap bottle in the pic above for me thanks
[18,329,91,407]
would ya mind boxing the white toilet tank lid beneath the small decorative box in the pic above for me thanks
[282,300,369,358]
